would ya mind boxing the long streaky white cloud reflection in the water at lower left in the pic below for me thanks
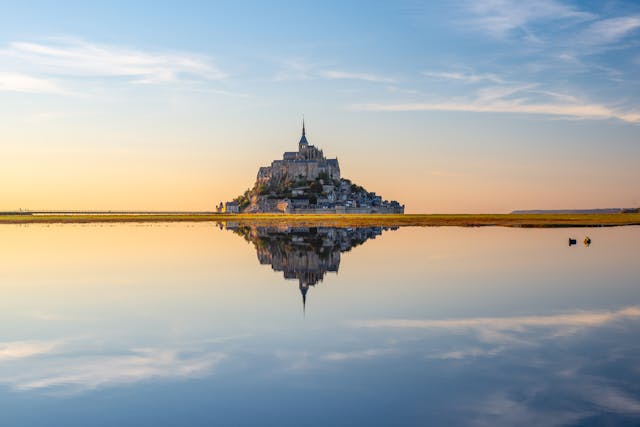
[0,348,224,392]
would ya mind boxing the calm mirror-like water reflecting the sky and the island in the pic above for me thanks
[0,224,640,426]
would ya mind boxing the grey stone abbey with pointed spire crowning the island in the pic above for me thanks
[257,121,340,184]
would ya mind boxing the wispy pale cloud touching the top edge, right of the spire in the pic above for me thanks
[465,0,595,39]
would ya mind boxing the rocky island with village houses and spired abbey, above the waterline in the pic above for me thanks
[218,122,404,213]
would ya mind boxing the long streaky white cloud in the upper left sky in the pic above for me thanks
[0,39,226,88]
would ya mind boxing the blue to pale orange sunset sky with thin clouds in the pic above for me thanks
[0,0,640,213]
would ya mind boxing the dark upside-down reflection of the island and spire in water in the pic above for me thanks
[225,223,397,310]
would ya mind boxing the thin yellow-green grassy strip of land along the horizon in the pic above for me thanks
[0,211,640,228]
